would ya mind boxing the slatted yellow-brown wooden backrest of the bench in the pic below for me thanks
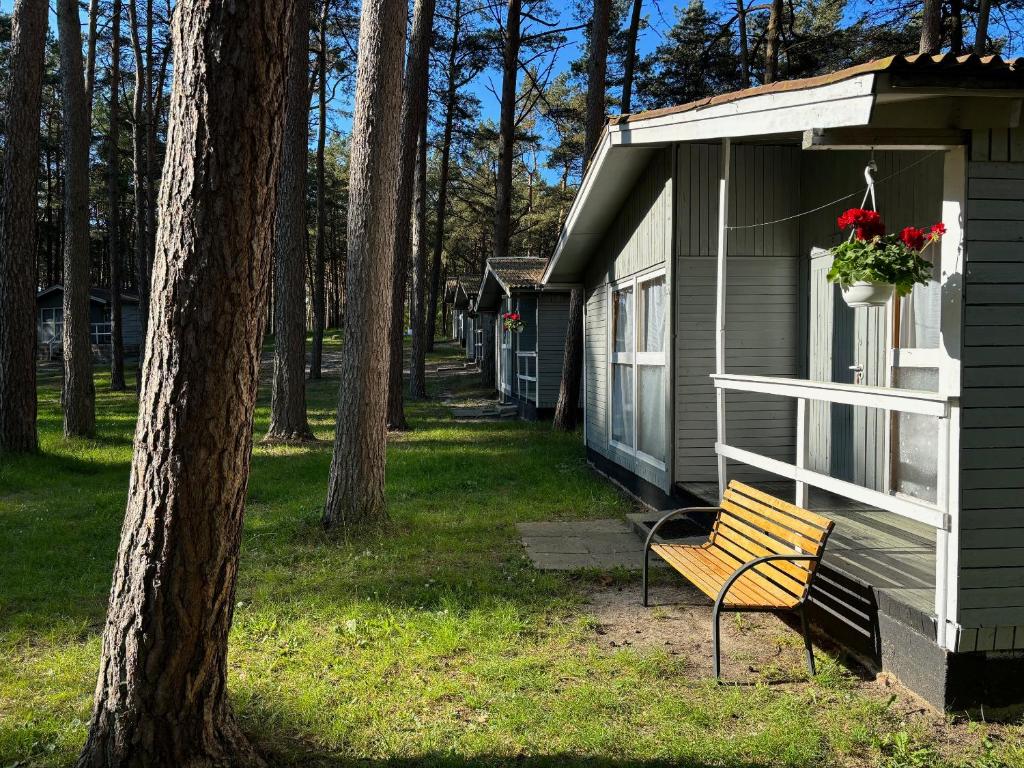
[710,480,834,598]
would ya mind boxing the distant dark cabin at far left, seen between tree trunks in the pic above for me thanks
[36,285,142,356]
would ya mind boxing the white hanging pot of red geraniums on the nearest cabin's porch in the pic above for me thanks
[828,208,946,307]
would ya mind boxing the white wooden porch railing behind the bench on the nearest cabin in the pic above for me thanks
[712,374,959,647]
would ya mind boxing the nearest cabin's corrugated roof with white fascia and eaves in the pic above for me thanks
[543,53,1024,284]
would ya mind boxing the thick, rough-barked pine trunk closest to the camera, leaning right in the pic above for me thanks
[79,0,291,768]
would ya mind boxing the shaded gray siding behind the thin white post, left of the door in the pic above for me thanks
[674,144,802,482]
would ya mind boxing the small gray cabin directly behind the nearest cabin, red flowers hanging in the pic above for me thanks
[476,257,569,419]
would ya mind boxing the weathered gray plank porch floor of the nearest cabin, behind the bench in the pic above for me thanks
[681,481,935,637]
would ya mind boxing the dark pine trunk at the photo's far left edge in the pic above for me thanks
[0,0,49,455]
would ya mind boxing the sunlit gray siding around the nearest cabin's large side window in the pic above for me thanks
[585,148,674,490]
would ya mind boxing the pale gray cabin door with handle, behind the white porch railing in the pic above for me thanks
[808,248,890,490]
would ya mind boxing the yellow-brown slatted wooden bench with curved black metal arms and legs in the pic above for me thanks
[643,480,834,678]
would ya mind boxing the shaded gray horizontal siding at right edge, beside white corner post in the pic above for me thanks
[957,129,1024,630]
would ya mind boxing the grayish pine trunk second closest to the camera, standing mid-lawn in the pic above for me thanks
[324,0,408,534]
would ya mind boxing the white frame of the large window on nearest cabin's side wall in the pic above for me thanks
[606,266,672,472]
